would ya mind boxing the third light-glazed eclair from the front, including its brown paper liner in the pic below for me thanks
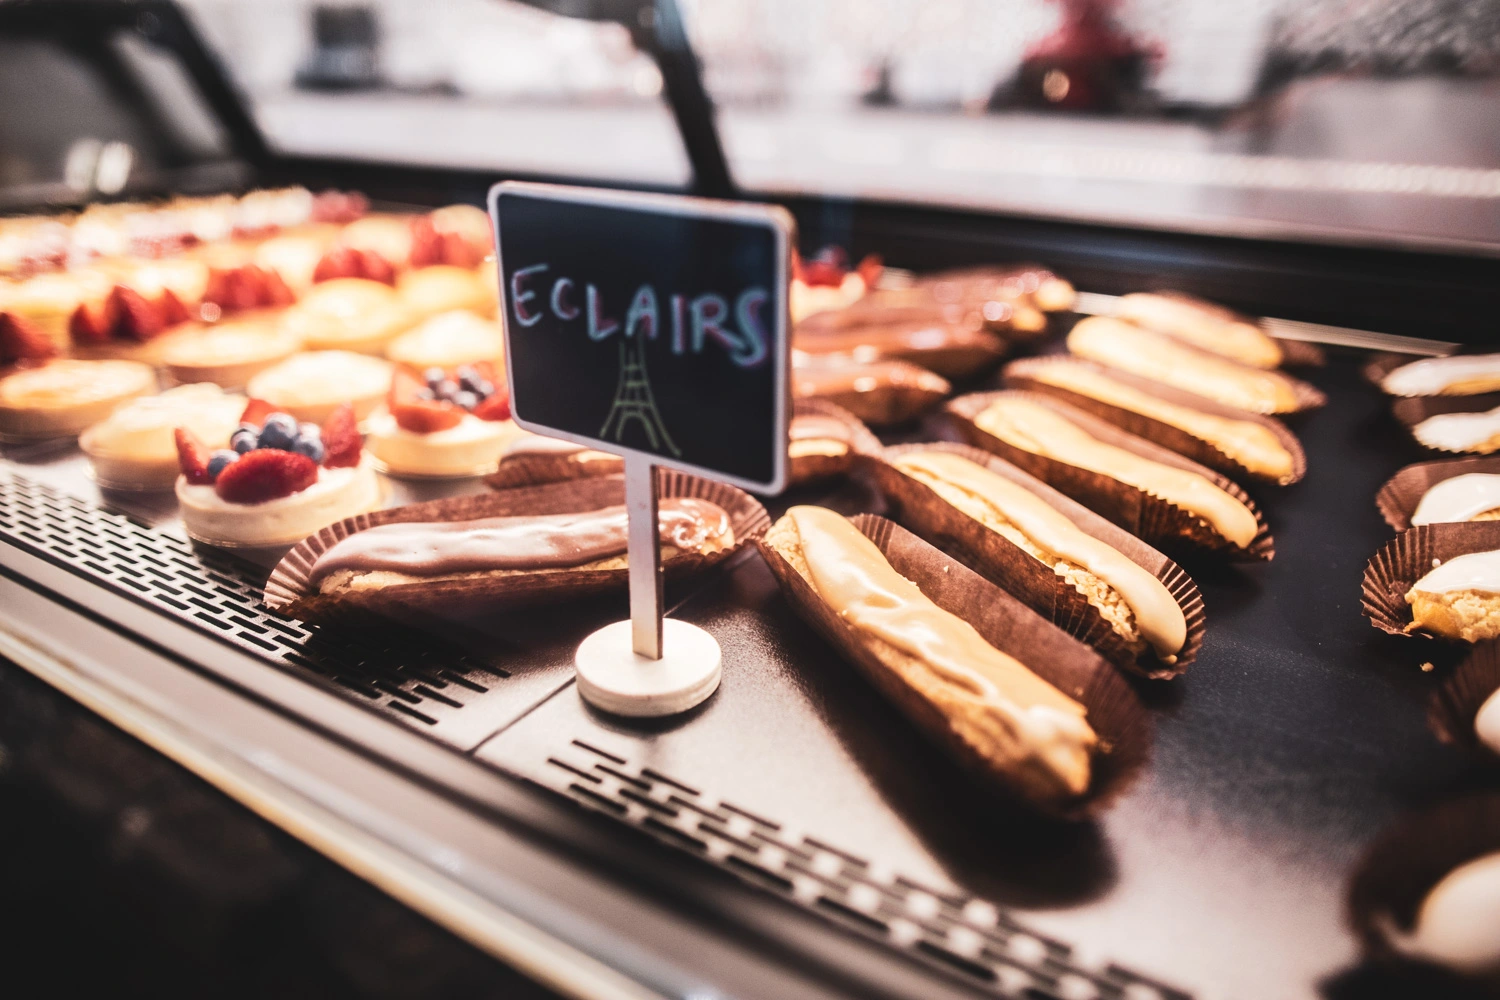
[948,391,1275,559]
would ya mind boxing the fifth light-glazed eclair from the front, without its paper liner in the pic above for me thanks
[1068,316,1298,414]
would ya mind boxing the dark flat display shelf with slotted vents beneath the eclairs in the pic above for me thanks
[0,340,1481,1000]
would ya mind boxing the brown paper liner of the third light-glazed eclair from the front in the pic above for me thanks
[945,388,1277,561]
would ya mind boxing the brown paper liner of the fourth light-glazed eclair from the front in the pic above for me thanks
[1004,358,1308,486]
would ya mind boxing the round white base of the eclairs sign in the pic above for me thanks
[573,618,722,718]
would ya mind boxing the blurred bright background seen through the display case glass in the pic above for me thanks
[0,0,1500,252]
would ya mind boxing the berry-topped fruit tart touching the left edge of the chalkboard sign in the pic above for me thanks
[369,361,519,477]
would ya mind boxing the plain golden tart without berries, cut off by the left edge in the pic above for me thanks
[0,358,156,439]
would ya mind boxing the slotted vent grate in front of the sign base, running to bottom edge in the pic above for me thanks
[548,739,1190,1000]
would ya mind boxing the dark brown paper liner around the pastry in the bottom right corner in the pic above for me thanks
[1347,792,1500,996]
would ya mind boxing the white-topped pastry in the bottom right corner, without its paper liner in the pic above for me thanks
[1388,852,1500,973]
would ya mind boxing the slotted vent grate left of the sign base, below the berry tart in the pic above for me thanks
[0,471,509,739]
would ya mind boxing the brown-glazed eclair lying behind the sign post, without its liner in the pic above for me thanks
[309,498,735,595]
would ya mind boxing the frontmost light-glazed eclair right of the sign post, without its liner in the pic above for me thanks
[788,507,1098,795]
